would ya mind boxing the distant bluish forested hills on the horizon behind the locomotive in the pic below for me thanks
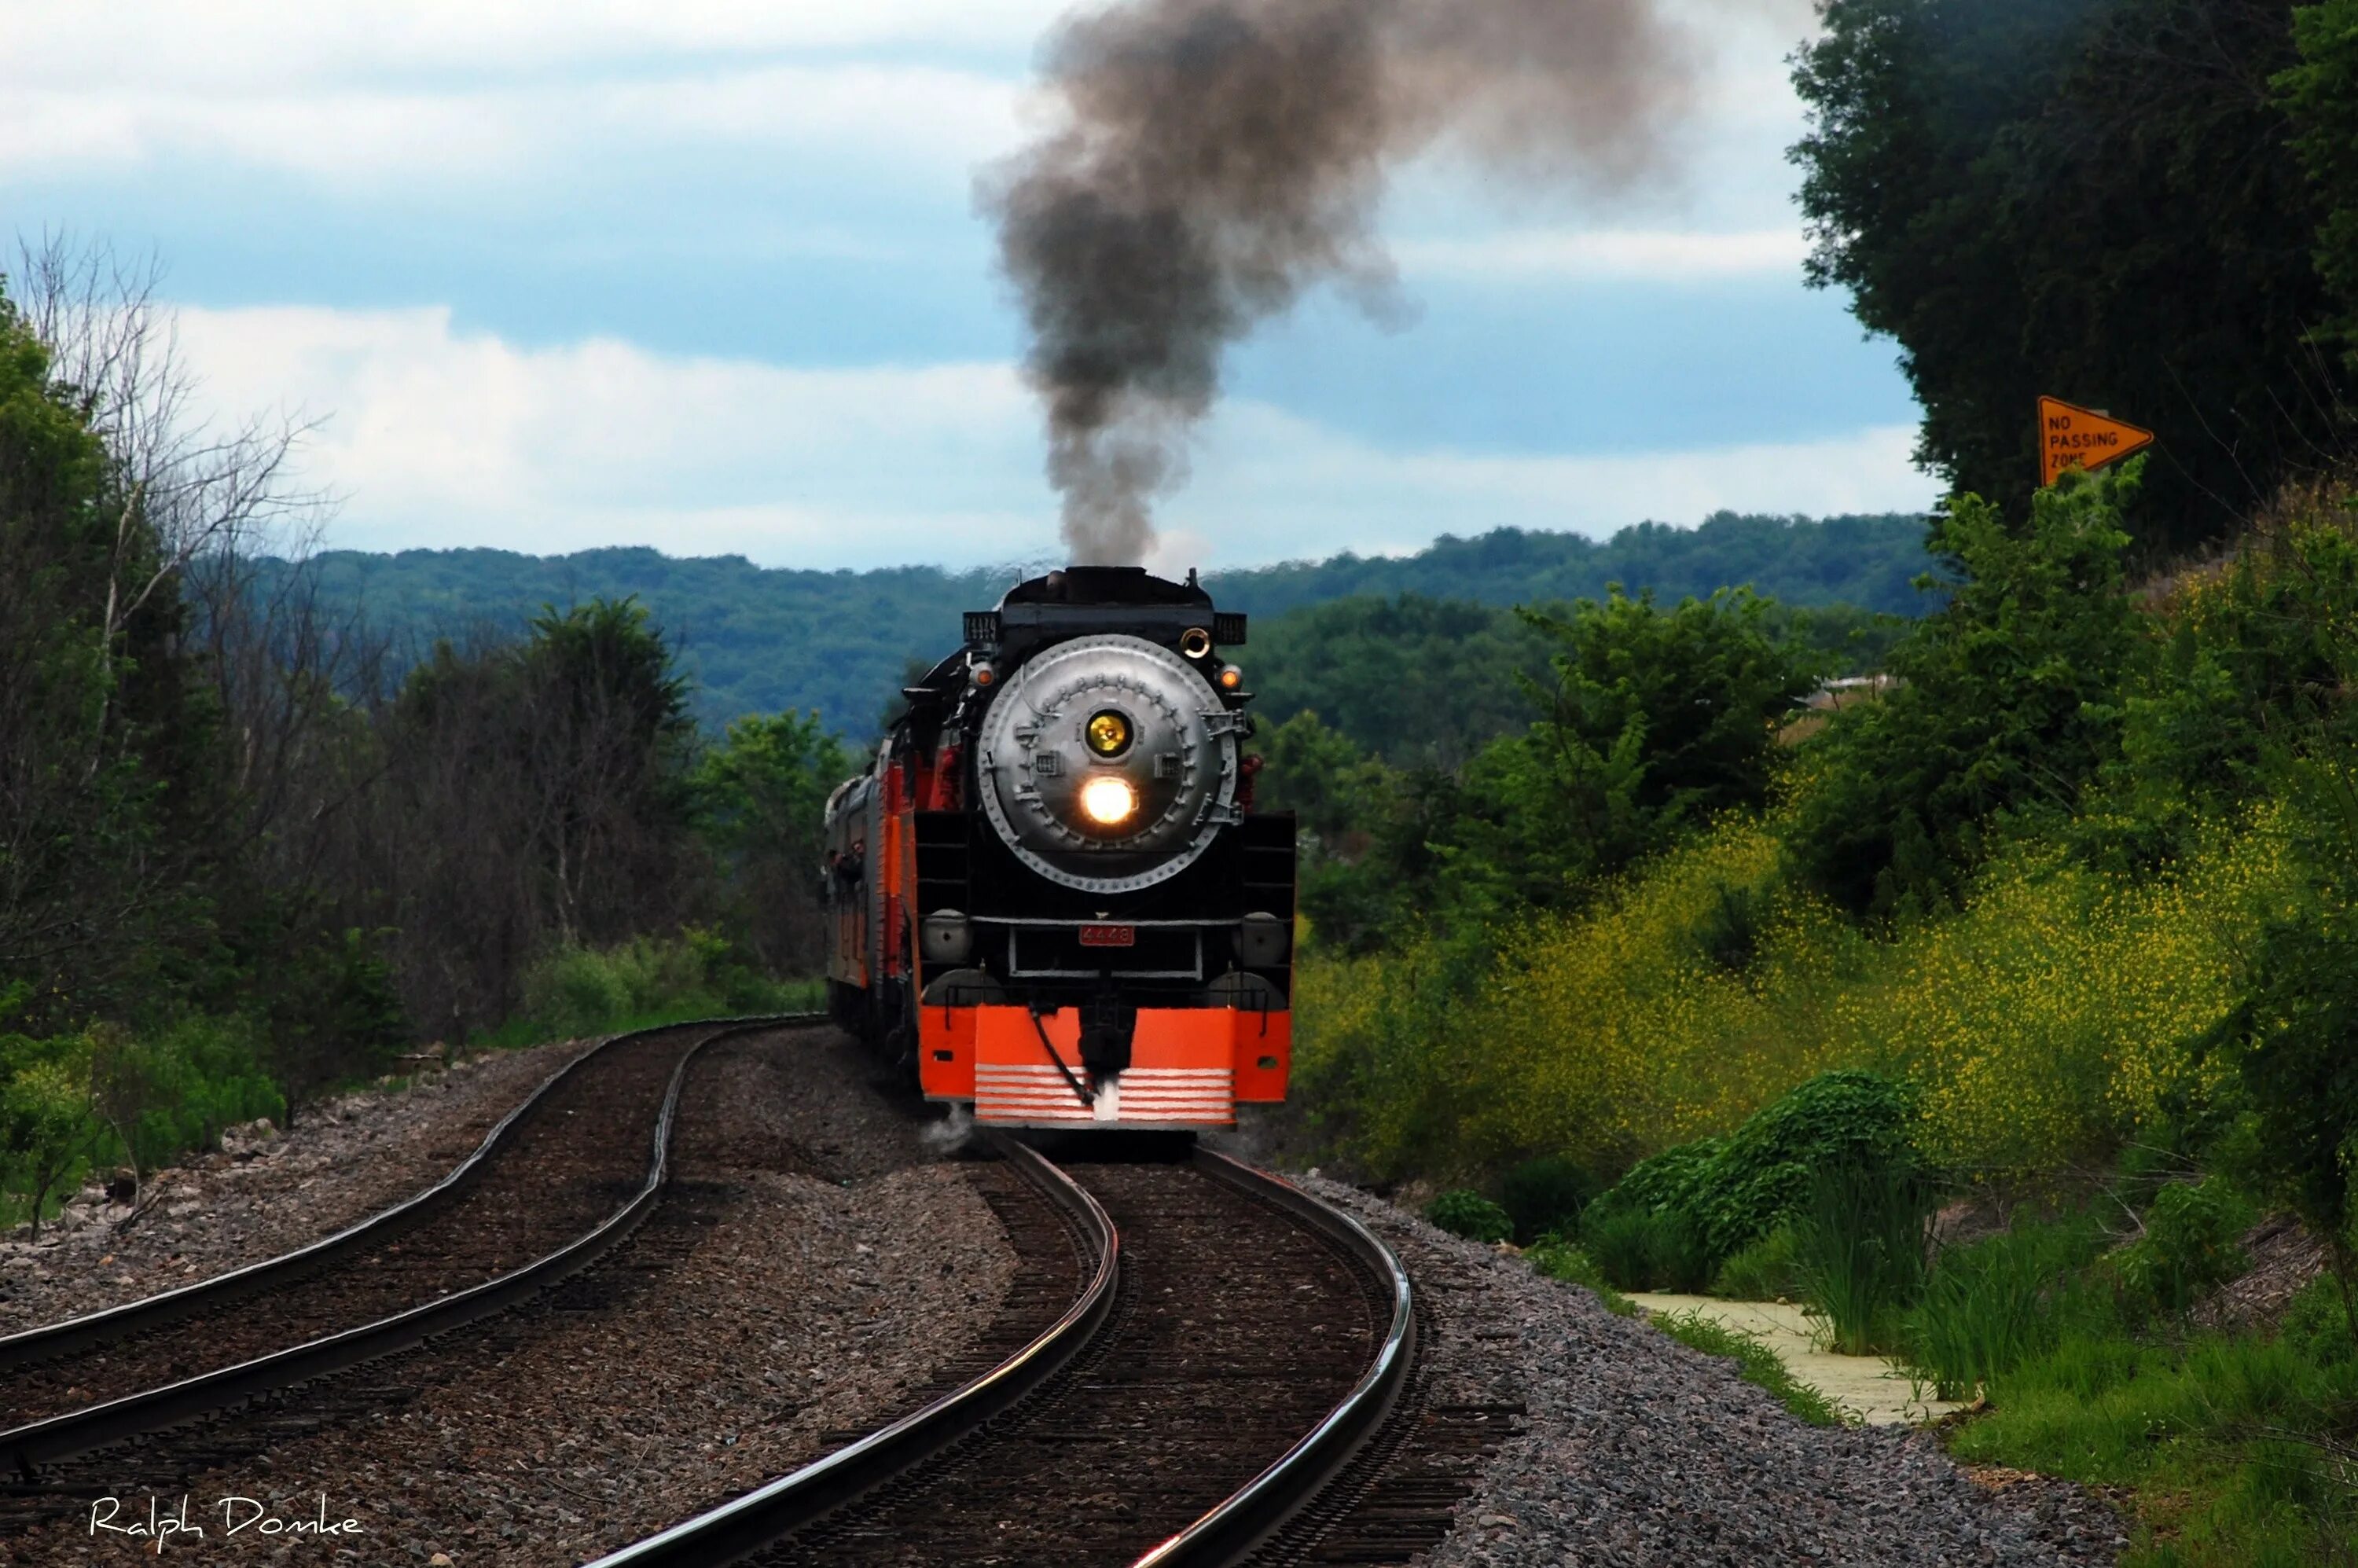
[281,512,1926,736]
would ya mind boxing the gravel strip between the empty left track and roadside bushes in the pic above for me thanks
[0,1040,590,1335]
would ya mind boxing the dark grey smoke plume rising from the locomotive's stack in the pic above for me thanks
[983,0,1691,564]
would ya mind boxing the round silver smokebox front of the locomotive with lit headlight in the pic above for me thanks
[979,634,1238,894]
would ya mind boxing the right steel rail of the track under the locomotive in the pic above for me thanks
[1132,1148,1417,1568]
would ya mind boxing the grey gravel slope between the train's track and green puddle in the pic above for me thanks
[1297,1177,2127,1568]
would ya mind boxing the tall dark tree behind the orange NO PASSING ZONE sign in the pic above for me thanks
[1794,0,2349,552]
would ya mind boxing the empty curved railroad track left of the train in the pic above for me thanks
[0,1014,821,1490]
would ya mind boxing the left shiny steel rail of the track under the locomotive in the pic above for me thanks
[575,1132,1122,1568]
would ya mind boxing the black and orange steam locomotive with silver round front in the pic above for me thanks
[823,566,1295,1129]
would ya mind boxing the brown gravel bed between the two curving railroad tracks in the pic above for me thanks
[0,1030,1014,1568]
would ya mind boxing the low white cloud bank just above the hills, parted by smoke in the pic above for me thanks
[182,309,1934,568]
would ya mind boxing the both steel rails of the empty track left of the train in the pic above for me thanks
[0,1014,825,1476]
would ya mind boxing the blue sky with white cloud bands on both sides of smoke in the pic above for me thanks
[0,0,1936,571]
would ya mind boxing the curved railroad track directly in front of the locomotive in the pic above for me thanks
[594,1139,1424,1568]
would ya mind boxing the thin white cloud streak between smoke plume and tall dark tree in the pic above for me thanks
[1391,229,1809,281]
